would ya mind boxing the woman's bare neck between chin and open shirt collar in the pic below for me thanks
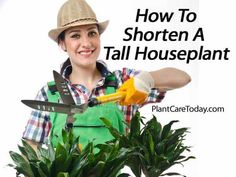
[69,64,102,92]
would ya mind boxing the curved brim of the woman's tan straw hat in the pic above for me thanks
[48,20,109,42]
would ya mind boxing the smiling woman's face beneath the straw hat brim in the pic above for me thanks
[59,25,100,67]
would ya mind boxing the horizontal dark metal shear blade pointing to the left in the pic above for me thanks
[21,100,88,115]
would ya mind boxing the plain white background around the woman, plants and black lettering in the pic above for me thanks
[0,0,236,177]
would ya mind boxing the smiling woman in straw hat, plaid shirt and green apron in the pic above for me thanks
[23,0,191,148]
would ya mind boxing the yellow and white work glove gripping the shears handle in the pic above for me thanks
[118,71,154,105]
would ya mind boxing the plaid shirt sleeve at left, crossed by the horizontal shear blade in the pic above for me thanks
[22,85,51,143]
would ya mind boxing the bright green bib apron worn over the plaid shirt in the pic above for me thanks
[47,77,125,147]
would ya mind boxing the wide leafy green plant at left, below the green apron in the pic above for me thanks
[9,130,133,177]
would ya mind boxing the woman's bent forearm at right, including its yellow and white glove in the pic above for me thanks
[118,68,191,105]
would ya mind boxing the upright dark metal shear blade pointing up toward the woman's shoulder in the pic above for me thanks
[53,71,75,105]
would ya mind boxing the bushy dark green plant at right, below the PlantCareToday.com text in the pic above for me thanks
[100,113,195,177]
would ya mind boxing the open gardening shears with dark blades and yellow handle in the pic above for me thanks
[21,71,126,122]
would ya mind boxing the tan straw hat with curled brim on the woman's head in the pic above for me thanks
[48,0,109,42]
